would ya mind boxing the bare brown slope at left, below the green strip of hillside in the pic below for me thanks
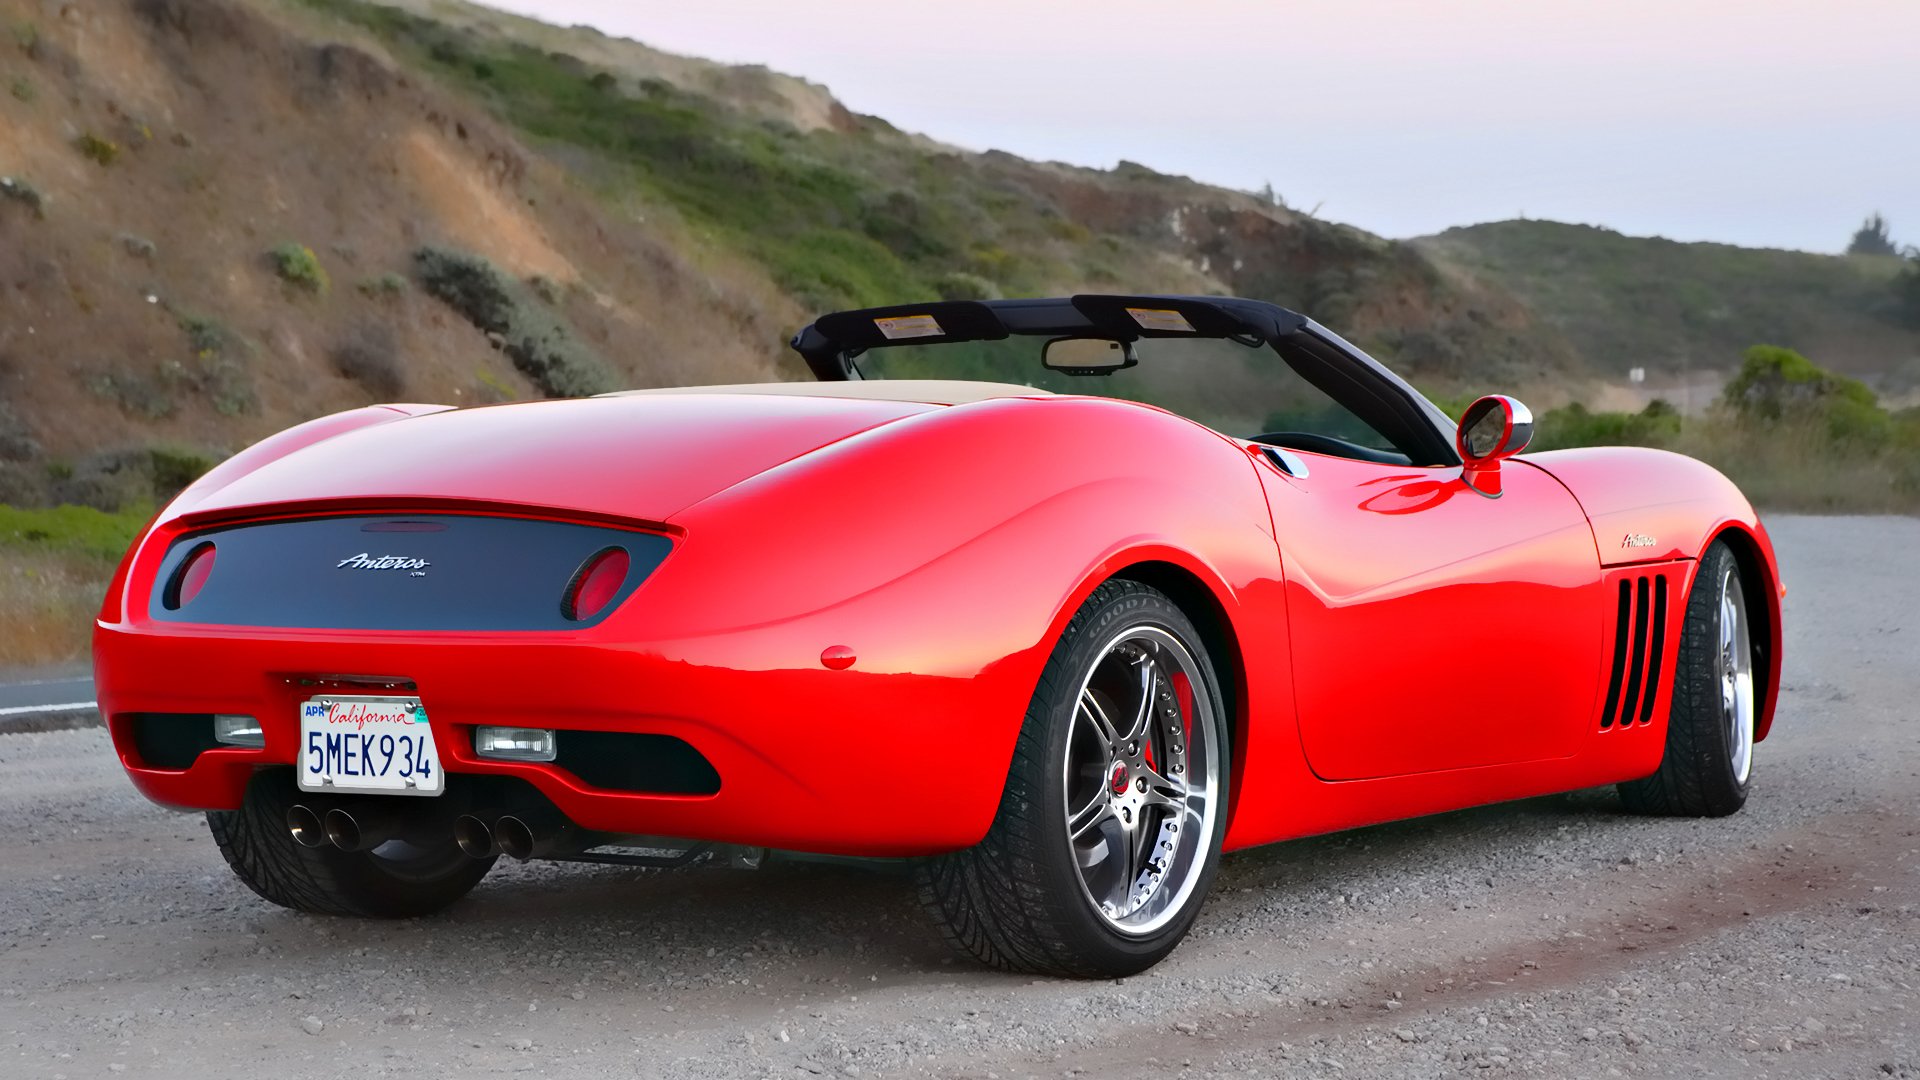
[0,0,803,509]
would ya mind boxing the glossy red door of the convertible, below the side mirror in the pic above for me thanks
[1263,454,1609,780]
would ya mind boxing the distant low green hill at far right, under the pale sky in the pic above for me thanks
[1415,221,1920,392]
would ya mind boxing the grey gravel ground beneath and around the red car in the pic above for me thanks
[0,517,1920,1080]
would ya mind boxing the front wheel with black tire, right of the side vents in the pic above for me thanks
[1620,542,1763,817]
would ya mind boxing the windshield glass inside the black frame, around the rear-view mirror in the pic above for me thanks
[854,334,1394,450]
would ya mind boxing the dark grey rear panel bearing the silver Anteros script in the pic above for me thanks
[150,515,672,630]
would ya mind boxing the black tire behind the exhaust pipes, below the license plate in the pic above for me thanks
[207,769,493,919]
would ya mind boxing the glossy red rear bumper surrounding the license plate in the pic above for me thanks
[94,625,1031,855]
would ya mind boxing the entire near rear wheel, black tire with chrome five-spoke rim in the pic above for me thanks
[920,580,1229,978]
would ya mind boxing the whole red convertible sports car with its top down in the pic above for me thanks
[94,296,1780,976]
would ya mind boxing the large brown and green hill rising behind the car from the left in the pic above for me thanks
[0,0,1576,505]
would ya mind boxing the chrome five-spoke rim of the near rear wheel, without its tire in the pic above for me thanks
[1062,626,1223,936]
